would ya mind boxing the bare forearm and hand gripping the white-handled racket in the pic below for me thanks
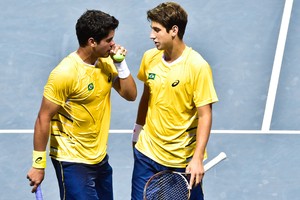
[186,104,212,186]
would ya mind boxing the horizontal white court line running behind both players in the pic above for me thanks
[0,129,300,135]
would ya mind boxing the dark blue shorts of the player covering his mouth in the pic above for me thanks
[52,156,113,200]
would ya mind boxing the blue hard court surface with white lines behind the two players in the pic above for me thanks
[0,0,300,200]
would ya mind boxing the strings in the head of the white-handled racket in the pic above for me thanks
[145,173,189,200]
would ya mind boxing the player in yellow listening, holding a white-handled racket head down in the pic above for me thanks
[131,2,218,200]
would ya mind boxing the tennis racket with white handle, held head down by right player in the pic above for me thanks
[143,152,226,200]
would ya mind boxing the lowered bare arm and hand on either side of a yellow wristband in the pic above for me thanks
[27,97,60,192]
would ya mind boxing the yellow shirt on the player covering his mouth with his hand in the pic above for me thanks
[44,52,117,164]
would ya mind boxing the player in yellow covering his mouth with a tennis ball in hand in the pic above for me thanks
[27,10,137,200]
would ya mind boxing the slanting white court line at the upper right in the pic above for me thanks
[261,0,293,131]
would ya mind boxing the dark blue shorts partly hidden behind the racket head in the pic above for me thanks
[131,148,204,200]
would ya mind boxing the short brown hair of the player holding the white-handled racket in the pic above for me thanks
[147,2,188,39]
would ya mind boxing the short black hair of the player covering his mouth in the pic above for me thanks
[76,10,119,47]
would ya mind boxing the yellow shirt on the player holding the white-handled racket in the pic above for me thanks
[136,47,218,168]
